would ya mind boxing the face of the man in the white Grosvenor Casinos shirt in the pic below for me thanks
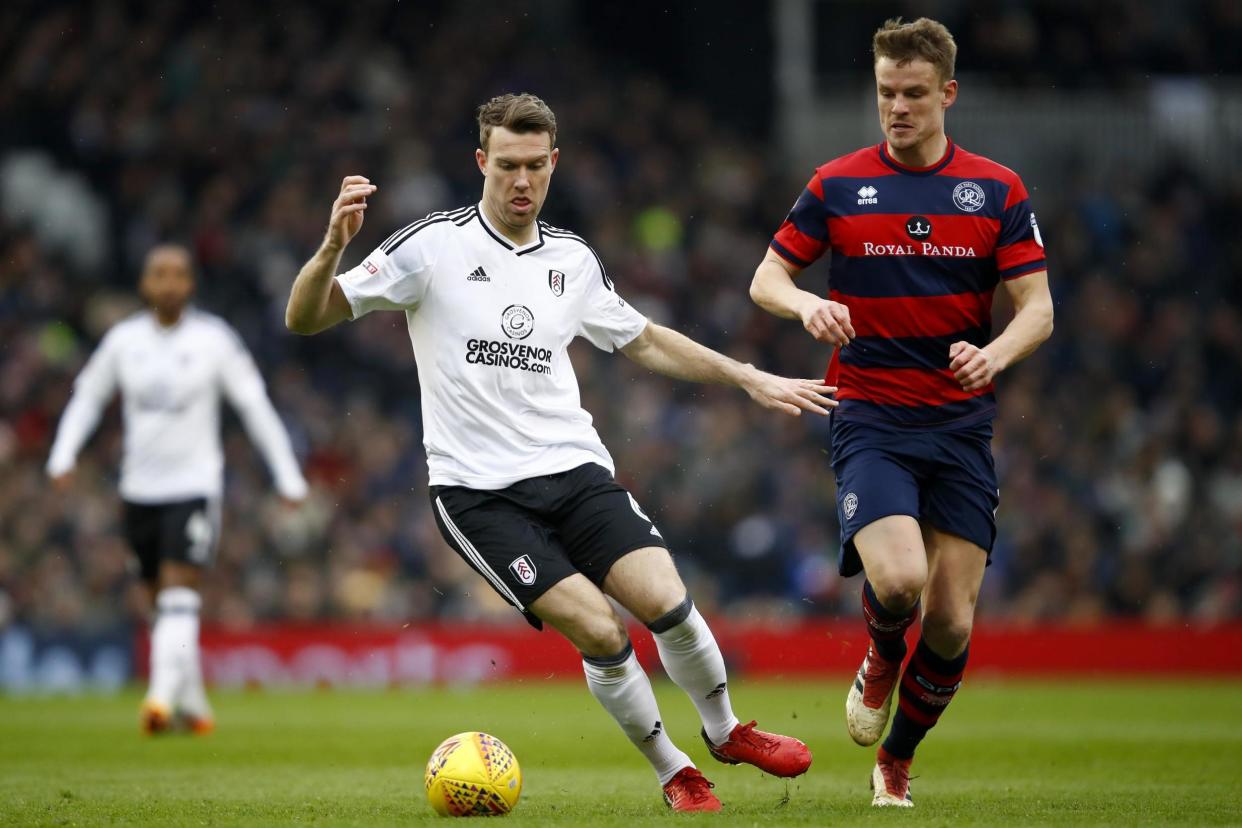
[474,127,560,230]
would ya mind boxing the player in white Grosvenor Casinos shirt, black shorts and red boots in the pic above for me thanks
[286,94,835,811]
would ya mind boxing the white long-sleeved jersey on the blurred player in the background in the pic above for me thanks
[47,308,307,503]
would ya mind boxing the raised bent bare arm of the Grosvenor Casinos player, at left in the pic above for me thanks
[284,175,378,334]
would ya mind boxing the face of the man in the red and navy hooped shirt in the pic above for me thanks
[876,57,958,150]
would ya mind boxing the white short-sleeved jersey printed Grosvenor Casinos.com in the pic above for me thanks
[337,205,647,489]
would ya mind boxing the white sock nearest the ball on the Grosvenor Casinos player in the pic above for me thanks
[582,644,694,785]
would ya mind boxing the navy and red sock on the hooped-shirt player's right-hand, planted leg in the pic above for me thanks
[884,638,970,758]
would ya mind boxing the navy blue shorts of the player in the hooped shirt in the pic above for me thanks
[832,416,1000,577]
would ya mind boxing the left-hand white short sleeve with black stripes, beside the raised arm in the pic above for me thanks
[337,225,438,319]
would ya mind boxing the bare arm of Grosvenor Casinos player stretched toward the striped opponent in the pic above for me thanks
[621,323,837,417]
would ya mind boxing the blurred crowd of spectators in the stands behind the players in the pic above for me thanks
[0,0,1242,628]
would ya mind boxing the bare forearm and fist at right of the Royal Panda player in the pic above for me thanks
[949,271,1052,391]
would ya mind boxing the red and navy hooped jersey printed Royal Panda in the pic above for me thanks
[771,142,1047,428]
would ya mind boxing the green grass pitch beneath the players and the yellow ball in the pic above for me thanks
[0,679,1242,828]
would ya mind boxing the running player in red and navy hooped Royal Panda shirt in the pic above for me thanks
[750,17,1052,807]
